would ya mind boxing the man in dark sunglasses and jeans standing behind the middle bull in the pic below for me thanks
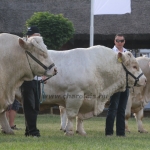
[105,34,129,137]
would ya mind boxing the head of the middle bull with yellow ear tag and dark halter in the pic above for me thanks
[118,51,146,87]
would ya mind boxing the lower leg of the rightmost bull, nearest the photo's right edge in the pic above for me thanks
[134,109,148,133]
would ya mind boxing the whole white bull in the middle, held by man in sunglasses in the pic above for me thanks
[41,45,146,135]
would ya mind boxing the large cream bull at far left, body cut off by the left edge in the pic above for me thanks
[0,33,56,134]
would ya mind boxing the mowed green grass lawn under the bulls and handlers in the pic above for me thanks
[0,114,150,150]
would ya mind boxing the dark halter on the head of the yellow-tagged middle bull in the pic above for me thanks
[122,63,143,88]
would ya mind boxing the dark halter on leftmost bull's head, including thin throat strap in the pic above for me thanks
[25,50,55,79]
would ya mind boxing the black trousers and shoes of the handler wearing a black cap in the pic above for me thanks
[21,80,40,136]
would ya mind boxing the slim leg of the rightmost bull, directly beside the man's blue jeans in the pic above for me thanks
[125,95,132,132]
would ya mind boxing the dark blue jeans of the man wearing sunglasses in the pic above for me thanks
[105,89,129,136]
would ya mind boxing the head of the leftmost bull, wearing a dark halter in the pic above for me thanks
[19,36,57,77]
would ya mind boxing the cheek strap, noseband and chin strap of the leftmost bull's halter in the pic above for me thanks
[25,51,57,80]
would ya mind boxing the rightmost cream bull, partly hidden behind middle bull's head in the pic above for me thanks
[125,57,150,133]
